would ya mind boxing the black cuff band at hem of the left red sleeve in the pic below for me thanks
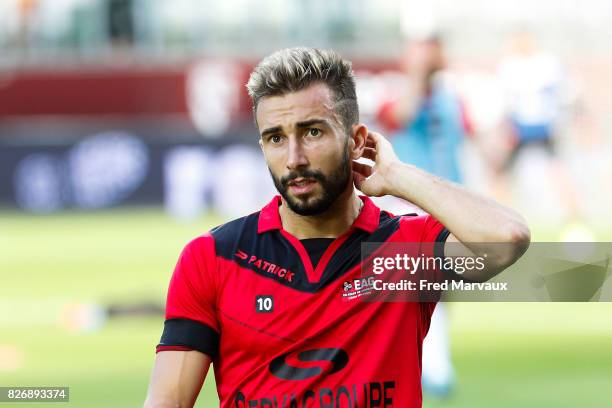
[158,319,219,358]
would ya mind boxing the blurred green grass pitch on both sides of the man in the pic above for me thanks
[0,208,612,408]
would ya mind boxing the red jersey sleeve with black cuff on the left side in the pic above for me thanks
[156,235,220,358]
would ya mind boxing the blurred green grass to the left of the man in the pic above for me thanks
[0,208,220,408]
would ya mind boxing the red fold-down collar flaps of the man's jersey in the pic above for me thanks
[257,195,380,234]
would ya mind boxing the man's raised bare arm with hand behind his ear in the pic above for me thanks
[353,133,531,281]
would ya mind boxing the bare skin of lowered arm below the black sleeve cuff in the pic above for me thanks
[144,350,211,408]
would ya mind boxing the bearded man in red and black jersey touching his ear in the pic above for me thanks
[145,48,529,407]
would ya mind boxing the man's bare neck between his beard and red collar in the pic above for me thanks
[278,190,363,239]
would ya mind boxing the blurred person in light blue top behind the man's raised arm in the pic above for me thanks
[379,37,469,182]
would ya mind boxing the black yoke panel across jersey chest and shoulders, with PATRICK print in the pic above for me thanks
[211,211,400,293]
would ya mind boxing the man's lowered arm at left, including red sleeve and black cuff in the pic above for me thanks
[145,234,220,408]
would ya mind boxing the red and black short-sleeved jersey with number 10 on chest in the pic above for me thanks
[157,196,448,408]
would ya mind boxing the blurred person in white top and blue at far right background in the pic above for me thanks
[498,30,579,231]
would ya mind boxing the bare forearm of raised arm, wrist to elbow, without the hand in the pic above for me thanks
[390,163,530,243]
